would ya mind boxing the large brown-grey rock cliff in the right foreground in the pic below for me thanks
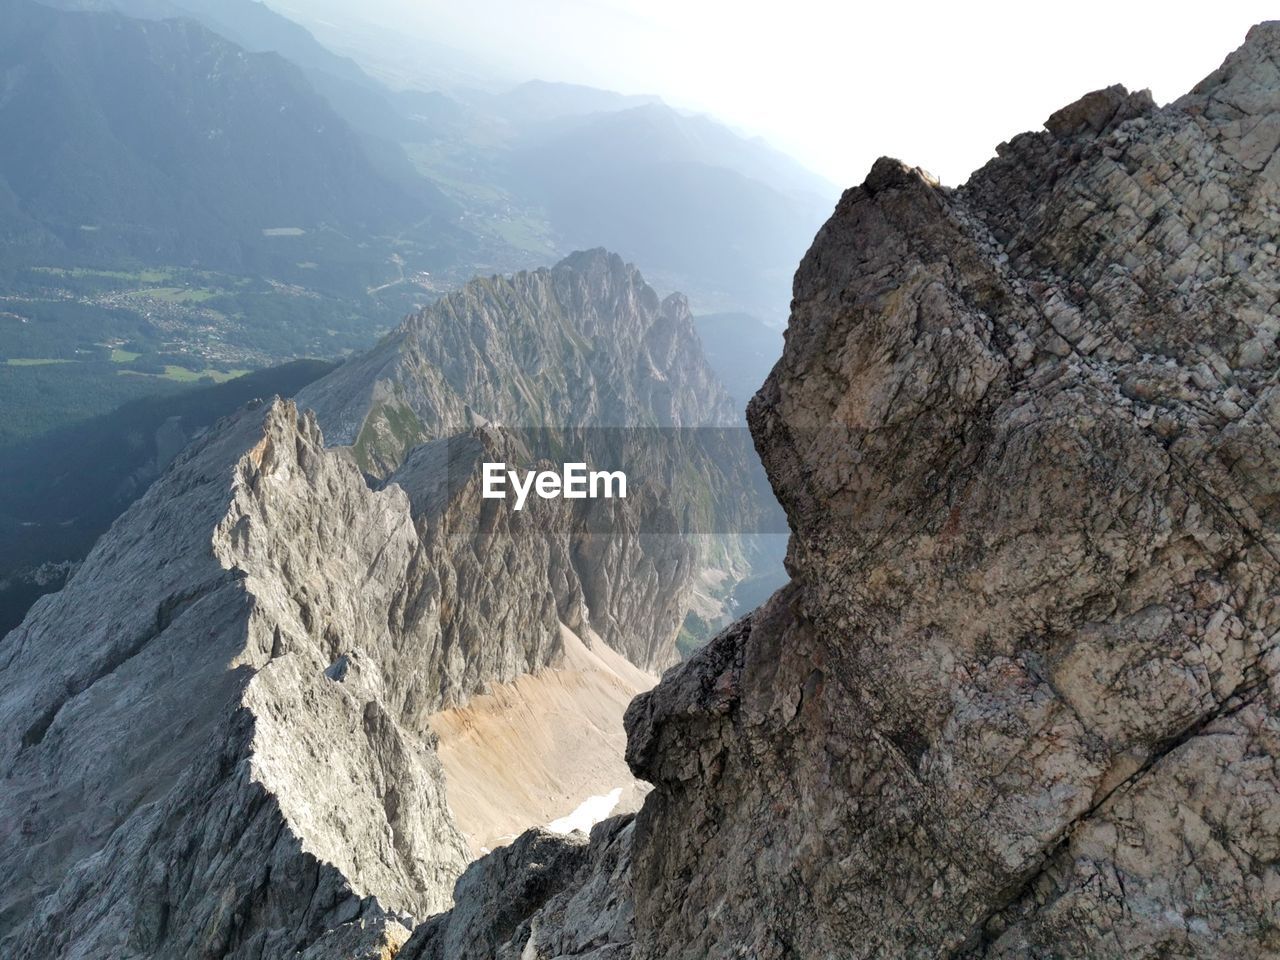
[415,23,1280,960]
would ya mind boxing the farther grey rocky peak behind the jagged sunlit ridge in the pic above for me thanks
[298,250,764,669]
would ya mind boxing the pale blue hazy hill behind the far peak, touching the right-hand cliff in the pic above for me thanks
[511,104,836,315]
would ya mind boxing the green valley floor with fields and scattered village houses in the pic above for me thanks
[0,265,409,447]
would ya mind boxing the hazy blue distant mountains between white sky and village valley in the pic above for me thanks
[20,0,836,316]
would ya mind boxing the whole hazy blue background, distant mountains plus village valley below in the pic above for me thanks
[0,0,836,455]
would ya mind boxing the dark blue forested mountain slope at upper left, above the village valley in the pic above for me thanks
[0,0,448,277]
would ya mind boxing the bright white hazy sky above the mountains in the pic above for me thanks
[304,0,1280,187]
